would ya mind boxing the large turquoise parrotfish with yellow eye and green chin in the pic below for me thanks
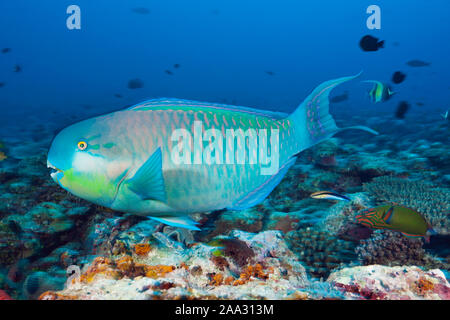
[47,75,377,230]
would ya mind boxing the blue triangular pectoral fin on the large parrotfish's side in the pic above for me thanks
[127,148,167,202]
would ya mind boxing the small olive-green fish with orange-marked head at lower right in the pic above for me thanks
[355,205,435,242]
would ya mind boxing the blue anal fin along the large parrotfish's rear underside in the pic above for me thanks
[227,157,297,210]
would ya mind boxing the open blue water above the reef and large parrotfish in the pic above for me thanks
[0,0,450,121]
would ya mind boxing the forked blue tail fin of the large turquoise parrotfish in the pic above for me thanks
[287,72,378,152]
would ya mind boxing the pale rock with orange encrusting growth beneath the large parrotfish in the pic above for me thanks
[40,231,309,299]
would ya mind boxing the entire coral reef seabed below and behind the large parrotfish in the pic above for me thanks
[0,110,450,299]
